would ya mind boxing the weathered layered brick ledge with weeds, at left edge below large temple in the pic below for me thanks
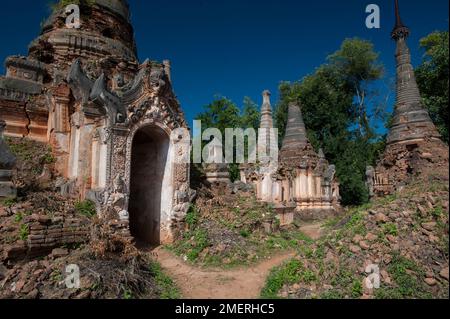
[0,193,91,263]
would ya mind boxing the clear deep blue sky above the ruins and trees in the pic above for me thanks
[0,0,449,132]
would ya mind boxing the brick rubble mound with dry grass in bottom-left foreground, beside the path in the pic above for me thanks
[0,249,172,299]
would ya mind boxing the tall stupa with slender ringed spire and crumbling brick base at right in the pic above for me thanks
[366,0,448,196]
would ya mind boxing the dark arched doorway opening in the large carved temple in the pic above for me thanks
[129,126,169,246]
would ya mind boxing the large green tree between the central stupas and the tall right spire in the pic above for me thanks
[275,38,385,204]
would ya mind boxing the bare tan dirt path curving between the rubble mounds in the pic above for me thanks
[155,248,295,299]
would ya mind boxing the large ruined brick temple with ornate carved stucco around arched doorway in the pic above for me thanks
[0,0,191,244]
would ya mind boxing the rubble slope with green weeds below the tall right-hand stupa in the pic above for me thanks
[265,181,449,299]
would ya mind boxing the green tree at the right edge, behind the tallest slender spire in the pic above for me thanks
[416,31,449,143]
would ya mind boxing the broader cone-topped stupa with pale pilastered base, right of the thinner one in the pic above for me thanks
[276,103,340,220]
